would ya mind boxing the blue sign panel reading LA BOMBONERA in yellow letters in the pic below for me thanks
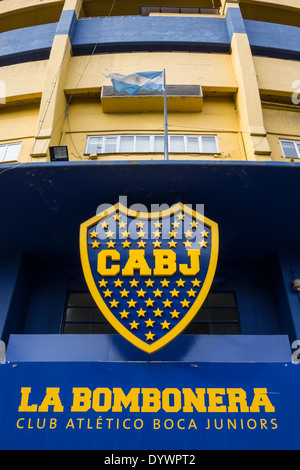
[0,362,300,450]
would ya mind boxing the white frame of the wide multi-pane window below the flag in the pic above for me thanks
[85,134,220,155]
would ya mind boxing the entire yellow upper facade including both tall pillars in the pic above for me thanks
[0,0,300,163]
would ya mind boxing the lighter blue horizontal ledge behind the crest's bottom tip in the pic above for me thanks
[6,334,291,363]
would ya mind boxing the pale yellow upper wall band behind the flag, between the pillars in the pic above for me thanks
[65,52,237,93]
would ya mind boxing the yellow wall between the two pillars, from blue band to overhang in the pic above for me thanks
[62,53,241,159]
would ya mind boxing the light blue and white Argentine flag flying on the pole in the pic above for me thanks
[108,72,164,95]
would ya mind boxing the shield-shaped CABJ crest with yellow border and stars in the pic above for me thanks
[80,203,218,353]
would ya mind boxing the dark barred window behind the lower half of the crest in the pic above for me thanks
[62,290,240,335]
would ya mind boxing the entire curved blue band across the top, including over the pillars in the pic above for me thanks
[0,14,300,66]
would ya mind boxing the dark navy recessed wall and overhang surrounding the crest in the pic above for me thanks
[0,162,300,364]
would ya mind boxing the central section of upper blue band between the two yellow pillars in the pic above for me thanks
[72,16,230,54]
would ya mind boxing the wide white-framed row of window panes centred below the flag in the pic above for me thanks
[85,135,219,154]
